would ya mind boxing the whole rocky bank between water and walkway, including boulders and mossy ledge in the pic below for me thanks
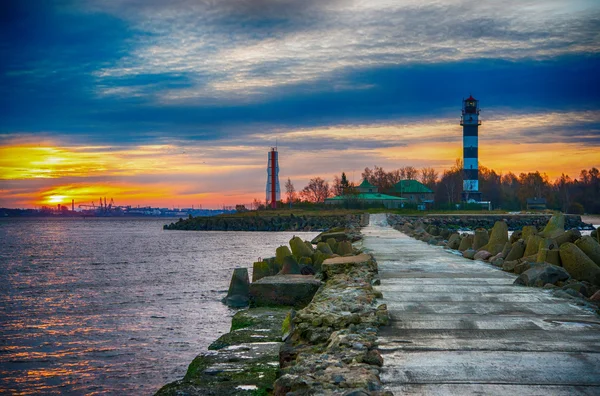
[157,219,388,395]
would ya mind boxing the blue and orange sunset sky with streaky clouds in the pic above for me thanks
[0,0,600,208]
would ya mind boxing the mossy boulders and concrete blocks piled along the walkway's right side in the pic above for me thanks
[389,214,600,312]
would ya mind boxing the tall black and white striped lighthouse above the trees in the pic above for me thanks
[460,95,481,202]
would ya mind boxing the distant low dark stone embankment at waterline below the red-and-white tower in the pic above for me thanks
[163,213,368,231]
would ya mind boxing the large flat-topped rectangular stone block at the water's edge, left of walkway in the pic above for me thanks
[250,275,321,308]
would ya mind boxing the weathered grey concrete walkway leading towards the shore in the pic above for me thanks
[362,215,600,396]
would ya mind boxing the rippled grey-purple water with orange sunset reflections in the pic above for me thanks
[0,218,316,394]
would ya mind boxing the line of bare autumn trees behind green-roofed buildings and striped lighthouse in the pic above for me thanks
[254,163,600,214]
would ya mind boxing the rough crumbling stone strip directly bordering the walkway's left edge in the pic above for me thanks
[274,254,389,395]
